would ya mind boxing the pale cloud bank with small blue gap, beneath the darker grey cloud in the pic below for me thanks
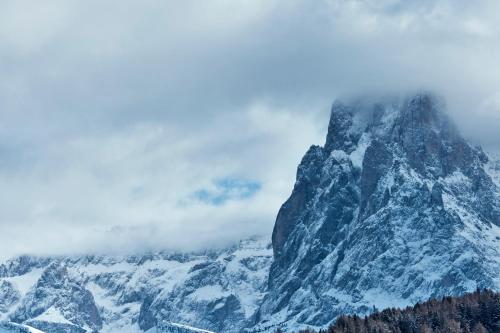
[0,105,322,256]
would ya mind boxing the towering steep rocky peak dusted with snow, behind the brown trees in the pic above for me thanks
[255,94,500,331]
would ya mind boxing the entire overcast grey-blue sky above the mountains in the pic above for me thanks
[0,0,500,257]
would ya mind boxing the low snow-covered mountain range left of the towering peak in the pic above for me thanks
[0,238,272,333]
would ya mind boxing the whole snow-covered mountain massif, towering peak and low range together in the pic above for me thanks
[0,94,500,333]
